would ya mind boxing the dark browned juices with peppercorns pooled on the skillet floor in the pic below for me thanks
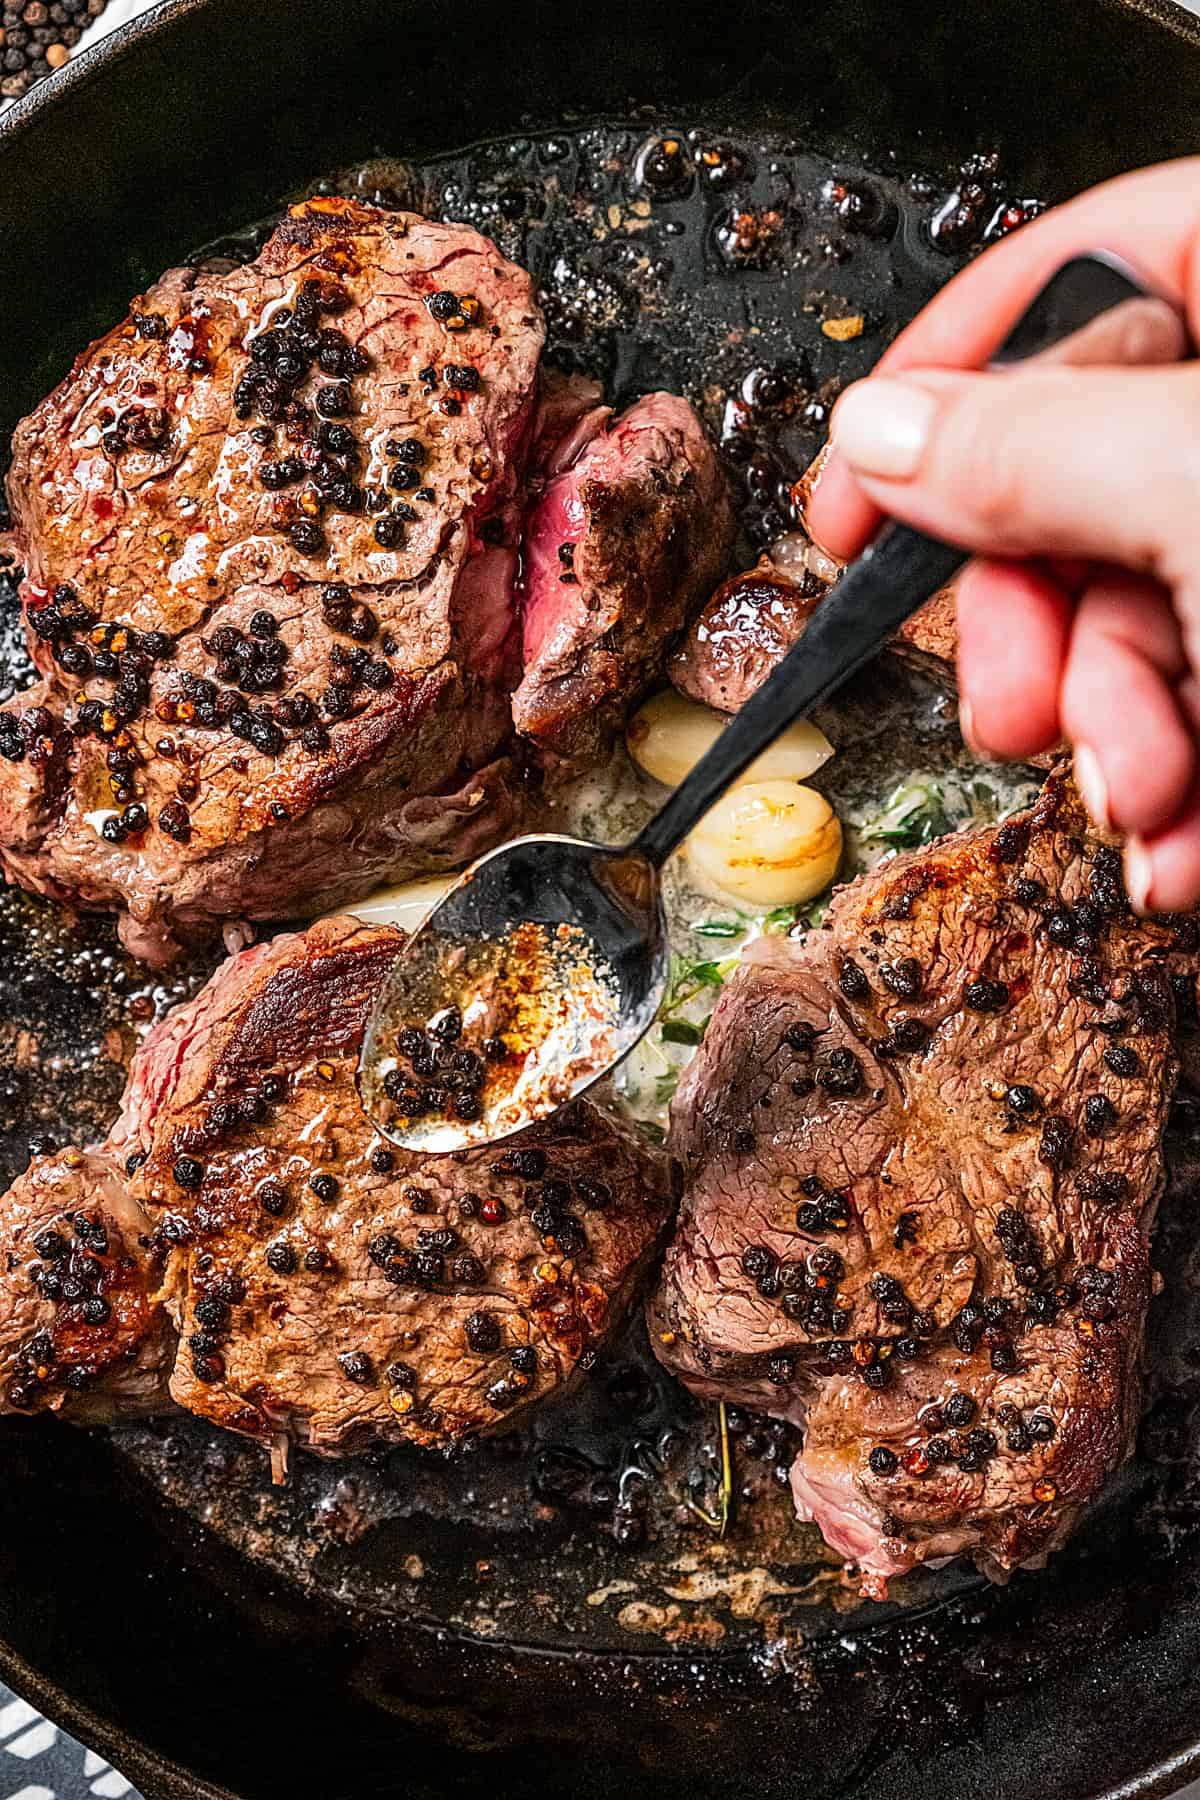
[0,121,1200,1669]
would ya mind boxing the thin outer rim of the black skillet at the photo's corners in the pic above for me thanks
[0,0,1200,1800]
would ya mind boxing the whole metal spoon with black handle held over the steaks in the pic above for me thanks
[358,254,1184,1154]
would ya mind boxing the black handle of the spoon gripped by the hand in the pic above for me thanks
[630,252,1148,868]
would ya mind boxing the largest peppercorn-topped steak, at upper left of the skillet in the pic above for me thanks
[0,198,543,959]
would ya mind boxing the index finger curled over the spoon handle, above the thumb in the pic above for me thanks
[806,157,1200,558]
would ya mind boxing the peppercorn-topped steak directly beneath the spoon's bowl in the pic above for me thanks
[0,918,675,1467]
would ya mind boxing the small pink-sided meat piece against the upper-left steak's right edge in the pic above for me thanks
[513,394,734,765]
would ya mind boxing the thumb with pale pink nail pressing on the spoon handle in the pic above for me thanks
[831,364,1200,585]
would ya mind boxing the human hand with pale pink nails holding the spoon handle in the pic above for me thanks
[808,158,1200,911]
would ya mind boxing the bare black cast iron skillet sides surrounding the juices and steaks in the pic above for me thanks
[0,0,1200,1800]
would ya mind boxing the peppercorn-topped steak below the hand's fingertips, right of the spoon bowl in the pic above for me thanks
[651,776,1196,1595]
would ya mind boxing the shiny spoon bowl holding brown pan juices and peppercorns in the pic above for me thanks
[358,835,671,1156]
